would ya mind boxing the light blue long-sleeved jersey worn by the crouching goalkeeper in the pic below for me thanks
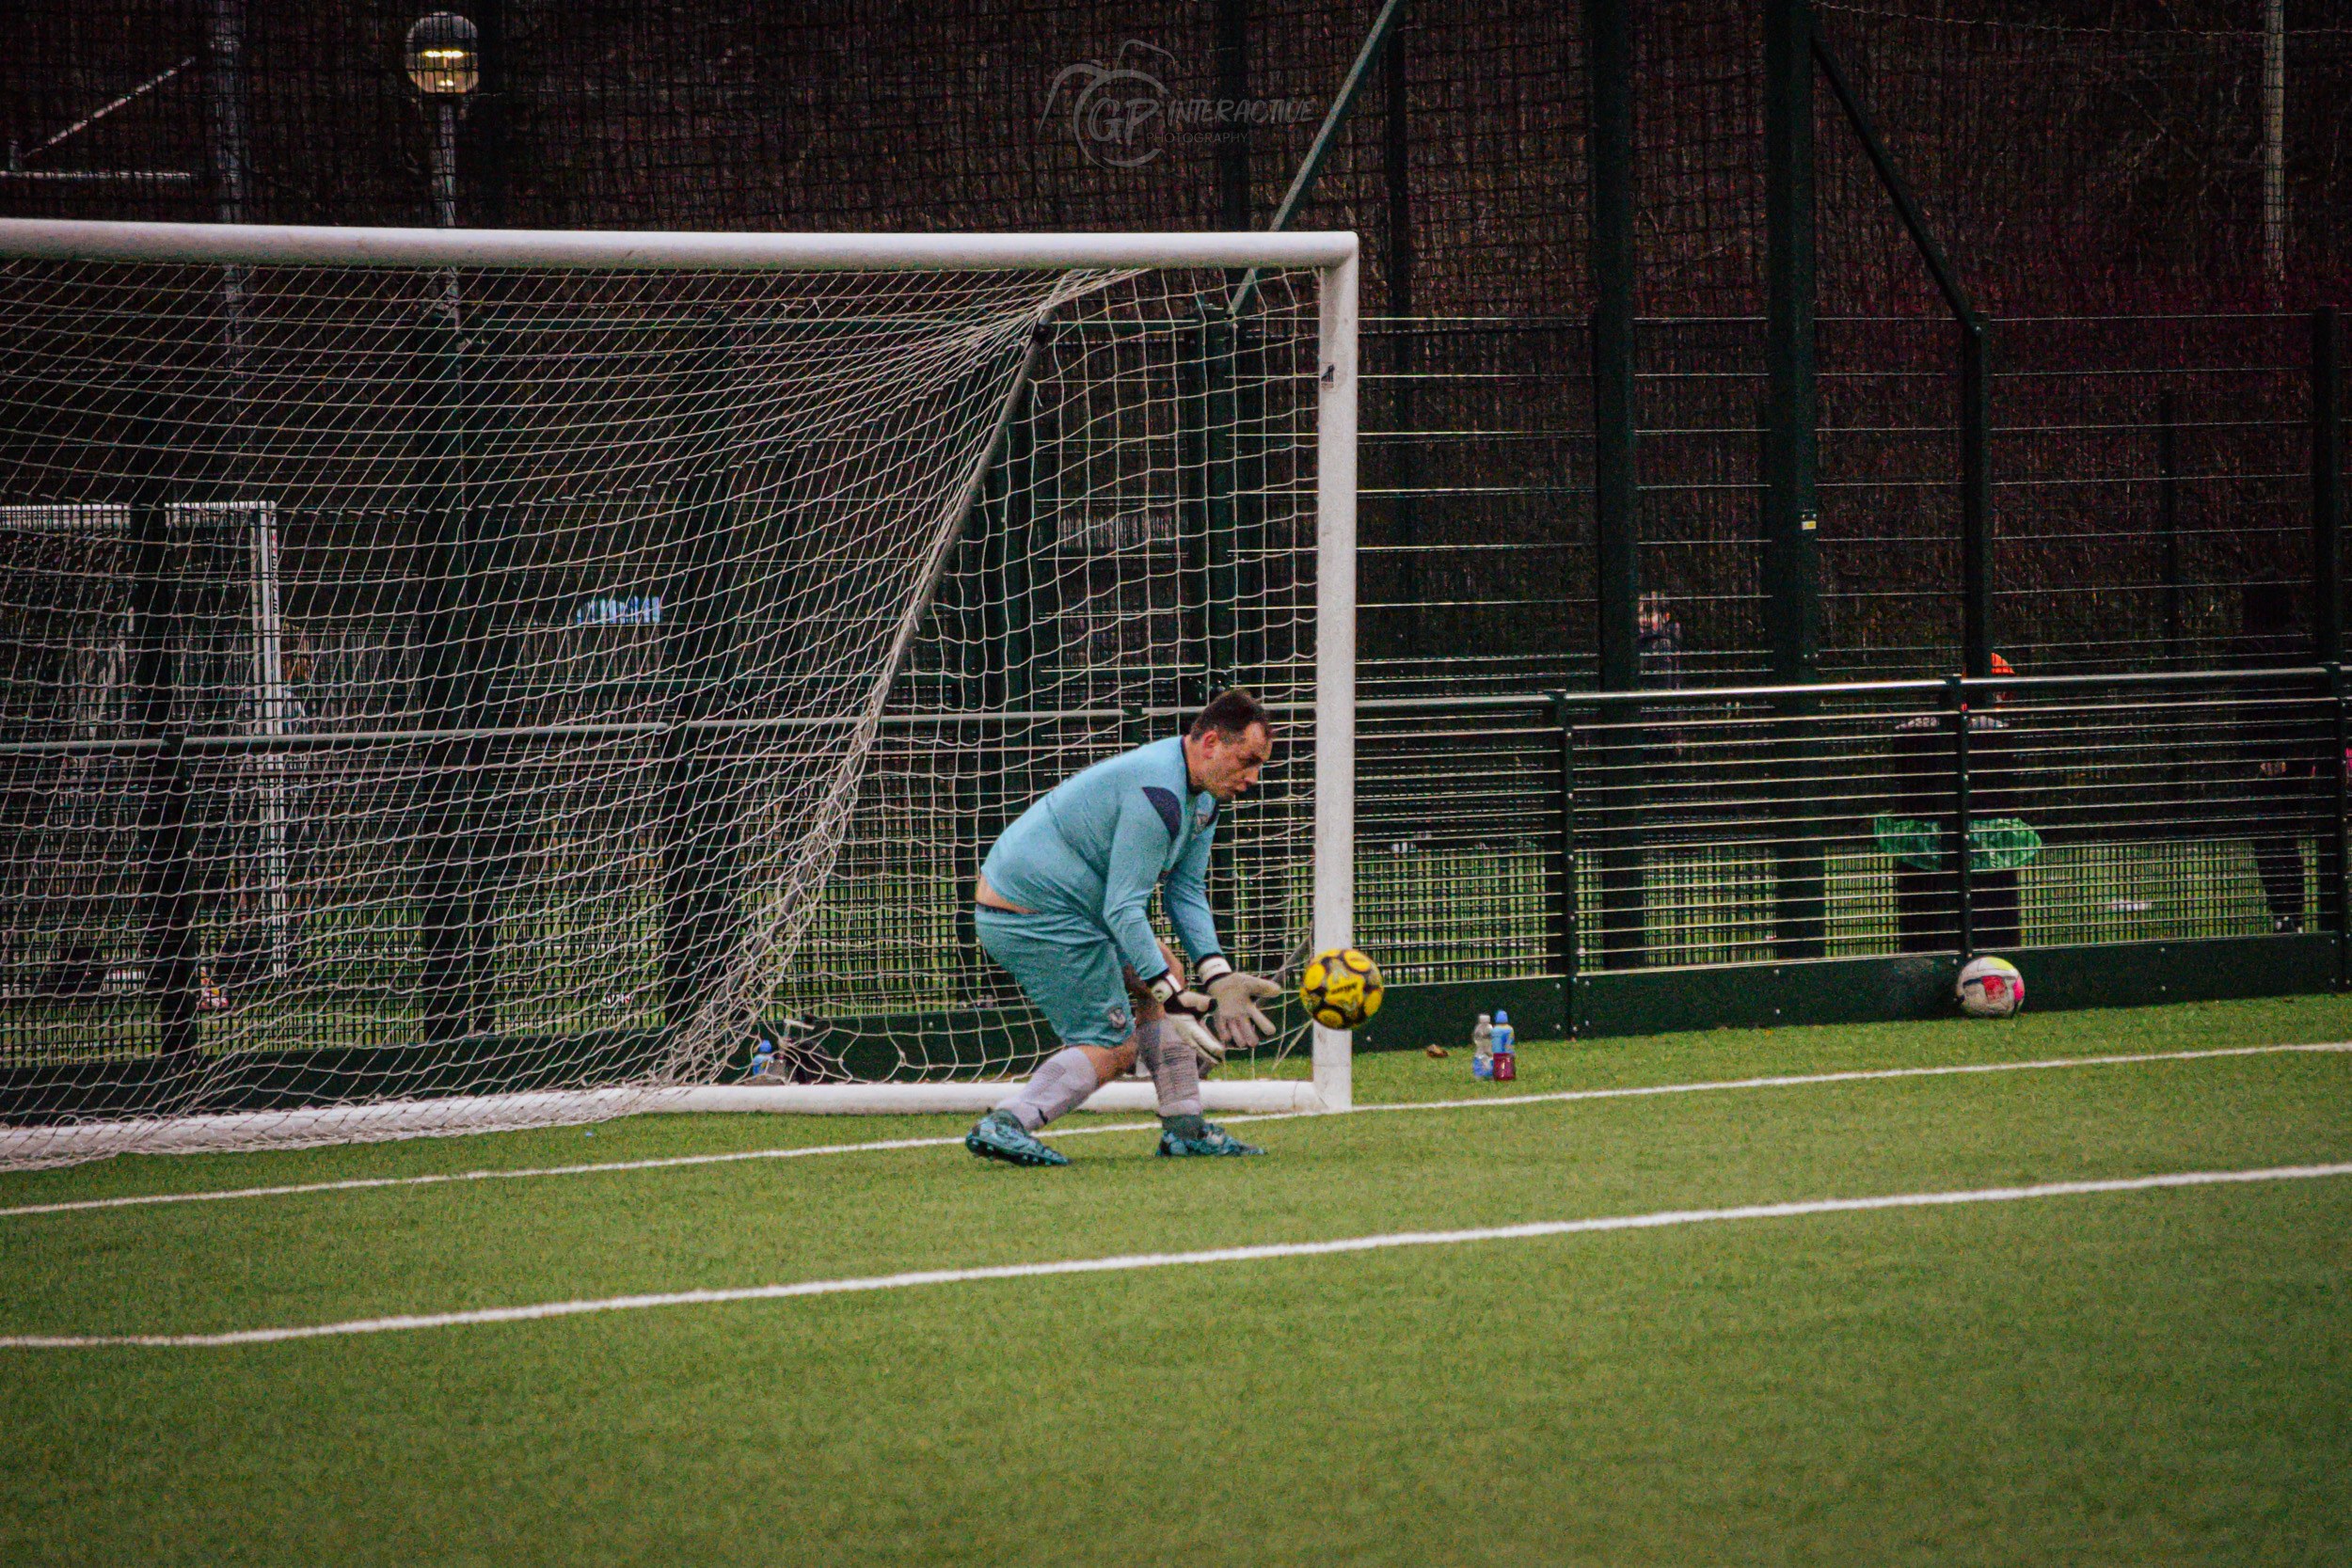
[981,736,1221,980]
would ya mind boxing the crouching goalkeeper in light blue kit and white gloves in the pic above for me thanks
[964,691,1279,1166]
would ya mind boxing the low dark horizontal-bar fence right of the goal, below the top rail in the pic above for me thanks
[1358,668,2347,983]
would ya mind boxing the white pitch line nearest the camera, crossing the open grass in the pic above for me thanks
[0,1162,2352,1350]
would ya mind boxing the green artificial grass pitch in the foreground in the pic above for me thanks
[0,999,2352,1563]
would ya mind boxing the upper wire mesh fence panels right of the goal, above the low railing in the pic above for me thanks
[1359,315,2343,696]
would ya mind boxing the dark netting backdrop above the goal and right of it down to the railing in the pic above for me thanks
[18,0,2352,691]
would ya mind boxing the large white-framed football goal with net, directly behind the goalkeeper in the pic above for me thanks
[0,221,1355,1166]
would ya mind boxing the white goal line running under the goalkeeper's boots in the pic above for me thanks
[0,1041,2352,1220]
